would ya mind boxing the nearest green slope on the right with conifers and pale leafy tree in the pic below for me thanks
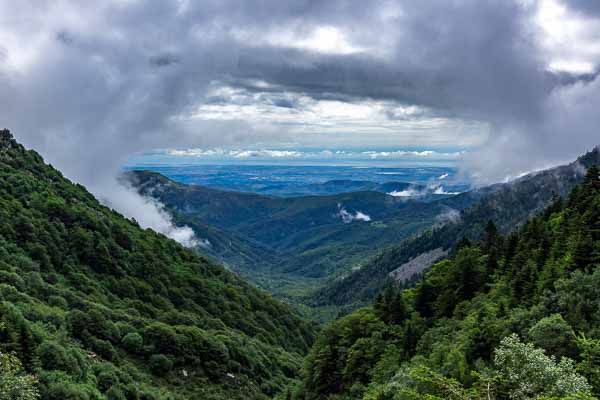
[287,166,600,400]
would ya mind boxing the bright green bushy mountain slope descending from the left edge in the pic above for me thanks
[0,130,315,400]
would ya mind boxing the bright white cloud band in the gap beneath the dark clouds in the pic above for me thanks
[188,81,489,148]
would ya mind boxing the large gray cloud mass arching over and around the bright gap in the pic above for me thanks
[0,0,599,208]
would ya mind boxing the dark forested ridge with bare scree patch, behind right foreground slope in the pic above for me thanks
[314,148,600,306]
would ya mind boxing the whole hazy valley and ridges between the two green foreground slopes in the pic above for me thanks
[125,150,600,315]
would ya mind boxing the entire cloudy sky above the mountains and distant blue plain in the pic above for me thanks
[0,0,600,242]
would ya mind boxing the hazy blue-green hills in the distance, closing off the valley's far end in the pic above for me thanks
[125,171,479,296]
